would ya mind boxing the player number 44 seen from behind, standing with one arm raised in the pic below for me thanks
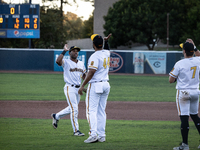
[78,34,111,143]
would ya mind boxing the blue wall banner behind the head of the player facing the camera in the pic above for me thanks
[54,51,86,71]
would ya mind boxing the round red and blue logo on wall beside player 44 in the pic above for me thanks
[109,52,124,72]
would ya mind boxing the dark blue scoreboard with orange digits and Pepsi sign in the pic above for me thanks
[0,4,40,38]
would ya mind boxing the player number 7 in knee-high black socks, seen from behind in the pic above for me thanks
[169,39,200,150]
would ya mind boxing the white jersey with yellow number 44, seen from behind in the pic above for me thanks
[88,49,110,83]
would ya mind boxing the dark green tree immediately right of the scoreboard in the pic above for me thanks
[33,6,66,48]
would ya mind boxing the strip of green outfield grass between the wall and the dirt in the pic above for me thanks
[0,73,176,102]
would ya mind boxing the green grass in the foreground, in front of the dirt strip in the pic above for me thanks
[0,118,199,150]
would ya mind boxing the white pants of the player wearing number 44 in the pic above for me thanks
[86,81,110,137]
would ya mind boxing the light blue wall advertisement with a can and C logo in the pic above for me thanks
[133,52,166,74]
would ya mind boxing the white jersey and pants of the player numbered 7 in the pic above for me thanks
[169,57,200,116]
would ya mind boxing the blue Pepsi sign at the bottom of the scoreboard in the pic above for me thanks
[7,30,40,39]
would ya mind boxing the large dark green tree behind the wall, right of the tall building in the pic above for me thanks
[104,0,199,50]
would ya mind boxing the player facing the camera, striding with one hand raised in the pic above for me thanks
[51,44,86,136]
